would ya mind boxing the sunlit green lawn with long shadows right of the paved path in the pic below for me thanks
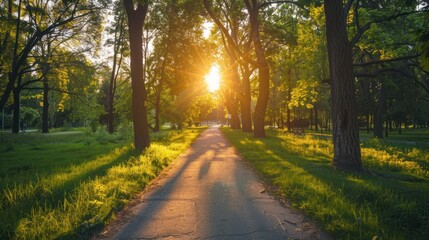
[223,128,429,239]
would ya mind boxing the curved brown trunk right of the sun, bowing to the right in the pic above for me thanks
[245,0,270,138]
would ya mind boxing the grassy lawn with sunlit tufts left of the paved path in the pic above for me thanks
[0,128,202,239]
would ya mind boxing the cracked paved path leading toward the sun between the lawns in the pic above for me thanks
[101,127,327,240]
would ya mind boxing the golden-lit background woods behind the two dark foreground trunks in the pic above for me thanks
[0,0,429,142]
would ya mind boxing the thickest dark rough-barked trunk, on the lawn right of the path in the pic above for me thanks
[324,0,362,171]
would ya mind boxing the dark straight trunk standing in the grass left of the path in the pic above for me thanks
[124,0,150,151]
